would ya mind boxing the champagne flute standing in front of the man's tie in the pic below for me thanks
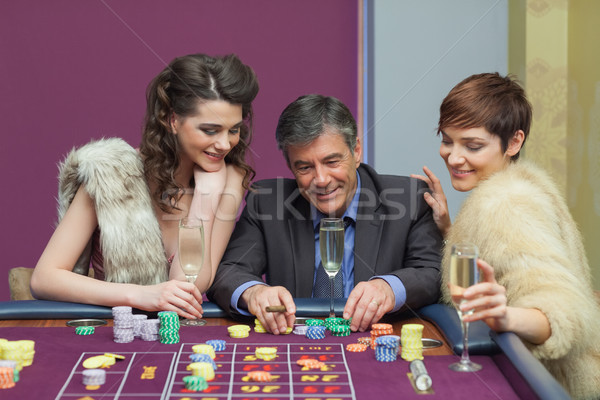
[319,218,344,318]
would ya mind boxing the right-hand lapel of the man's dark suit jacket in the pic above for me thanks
[354,168,383,285]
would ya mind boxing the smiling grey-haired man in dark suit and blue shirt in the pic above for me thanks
[207,95,442,334]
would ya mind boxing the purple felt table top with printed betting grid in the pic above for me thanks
[0,326,519,400]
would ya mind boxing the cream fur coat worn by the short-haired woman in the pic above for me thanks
[442,161,600,399]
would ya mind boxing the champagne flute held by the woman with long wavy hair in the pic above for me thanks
[179,217,206,326]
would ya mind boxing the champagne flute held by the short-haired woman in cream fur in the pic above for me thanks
[449,243,481,372]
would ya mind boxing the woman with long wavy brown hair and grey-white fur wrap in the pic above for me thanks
[31,54,258,318]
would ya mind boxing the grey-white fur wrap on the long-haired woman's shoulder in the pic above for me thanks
[58,138,168,285]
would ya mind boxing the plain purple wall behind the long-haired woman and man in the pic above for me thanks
[0,0,358,300]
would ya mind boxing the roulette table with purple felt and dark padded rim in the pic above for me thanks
[0,299,569,400]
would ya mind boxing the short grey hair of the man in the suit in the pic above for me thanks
[275,94,357,161]
